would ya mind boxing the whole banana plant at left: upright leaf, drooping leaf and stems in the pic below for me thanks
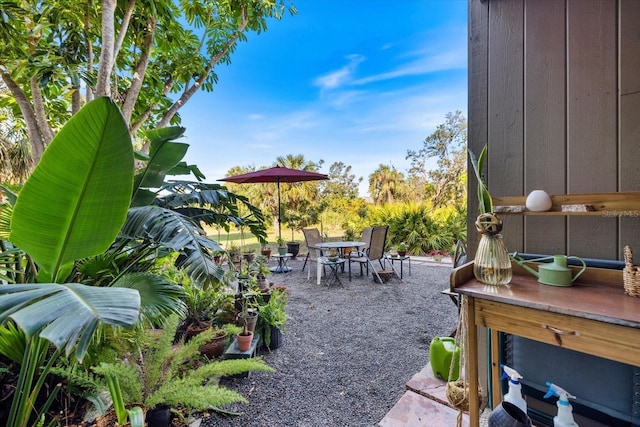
[0,98,140,426]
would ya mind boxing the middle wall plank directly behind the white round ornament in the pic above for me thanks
[522,0,567,254]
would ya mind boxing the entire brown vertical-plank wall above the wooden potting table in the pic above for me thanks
[468,0,640,260]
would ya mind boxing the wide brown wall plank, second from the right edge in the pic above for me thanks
[567,0,618,259]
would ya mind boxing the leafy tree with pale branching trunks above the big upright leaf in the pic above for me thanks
[0,0,297,171]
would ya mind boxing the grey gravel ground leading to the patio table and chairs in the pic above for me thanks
[201,257,457,427]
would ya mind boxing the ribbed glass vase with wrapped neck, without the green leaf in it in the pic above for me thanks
[473,214,512,286]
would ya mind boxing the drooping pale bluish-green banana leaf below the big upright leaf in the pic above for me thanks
[0,283,140,360]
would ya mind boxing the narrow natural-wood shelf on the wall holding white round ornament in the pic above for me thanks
[493,191,640,218]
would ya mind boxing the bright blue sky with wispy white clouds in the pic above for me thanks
[180,0,467,196]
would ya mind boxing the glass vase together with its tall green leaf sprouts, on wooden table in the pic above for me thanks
[469,145,512,285]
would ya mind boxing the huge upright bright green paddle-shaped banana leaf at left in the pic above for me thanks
[10,97,133,281]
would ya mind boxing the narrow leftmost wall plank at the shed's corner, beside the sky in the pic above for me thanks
[467,0,489,259]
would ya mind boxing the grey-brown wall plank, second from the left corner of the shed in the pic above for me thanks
[487,0,524,251]
